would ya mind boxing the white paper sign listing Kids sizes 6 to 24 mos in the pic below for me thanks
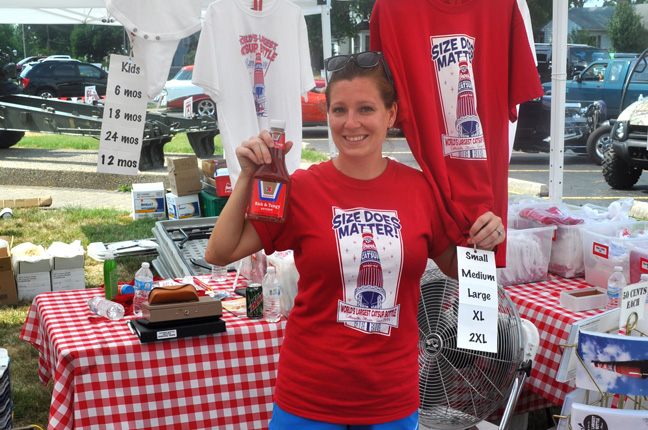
[97,54,148,175]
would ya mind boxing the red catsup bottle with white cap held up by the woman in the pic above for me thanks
[247,119,290,223]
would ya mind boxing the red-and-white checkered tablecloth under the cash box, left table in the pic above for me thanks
[20,274,286,430]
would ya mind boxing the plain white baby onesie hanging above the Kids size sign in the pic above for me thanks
[106,0,202,99]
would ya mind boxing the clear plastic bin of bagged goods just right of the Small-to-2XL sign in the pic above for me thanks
[497,217,556,285]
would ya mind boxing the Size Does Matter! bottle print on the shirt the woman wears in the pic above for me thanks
[333,207,403,336]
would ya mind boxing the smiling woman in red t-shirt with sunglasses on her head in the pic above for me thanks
[205,51,505,430]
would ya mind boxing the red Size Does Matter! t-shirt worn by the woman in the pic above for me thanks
[254,161,450,425]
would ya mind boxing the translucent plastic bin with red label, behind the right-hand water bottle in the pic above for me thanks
[582,221,648,288]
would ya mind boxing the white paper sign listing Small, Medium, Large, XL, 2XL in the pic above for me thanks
[457,246,498,352]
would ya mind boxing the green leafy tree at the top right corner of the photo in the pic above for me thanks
[606,0,648,52]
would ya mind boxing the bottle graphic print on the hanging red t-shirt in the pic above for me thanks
[430,34,487,160]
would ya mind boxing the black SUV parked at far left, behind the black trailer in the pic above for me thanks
[21,60,108,97]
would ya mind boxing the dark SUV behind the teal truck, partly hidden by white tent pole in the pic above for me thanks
[535,43,611,83]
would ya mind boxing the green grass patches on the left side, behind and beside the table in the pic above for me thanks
[0,133,328,429]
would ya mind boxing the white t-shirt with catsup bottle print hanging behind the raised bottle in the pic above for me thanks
[192,0,315,184]
